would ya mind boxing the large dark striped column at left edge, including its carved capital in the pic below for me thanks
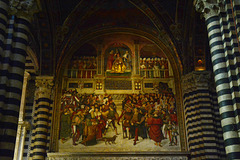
[0,0,38,159]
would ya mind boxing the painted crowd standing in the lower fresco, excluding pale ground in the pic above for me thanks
[60,91,178,147]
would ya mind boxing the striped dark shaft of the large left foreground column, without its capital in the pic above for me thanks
[0,1,29,159]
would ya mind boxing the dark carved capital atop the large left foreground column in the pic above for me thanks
[9,0,41,20]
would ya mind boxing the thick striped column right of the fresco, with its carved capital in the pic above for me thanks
[182,71,226,160]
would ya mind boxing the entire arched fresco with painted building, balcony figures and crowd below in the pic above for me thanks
[59,36,180,152]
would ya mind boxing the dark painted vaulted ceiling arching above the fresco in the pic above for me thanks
[30,0,209,75]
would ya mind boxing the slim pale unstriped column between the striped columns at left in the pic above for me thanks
[14,71,30,160]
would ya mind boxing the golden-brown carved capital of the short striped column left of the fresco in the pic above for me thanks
[35,76,54,97]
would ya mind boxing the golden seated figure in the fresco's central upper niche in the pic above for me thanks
[111,53,126,73]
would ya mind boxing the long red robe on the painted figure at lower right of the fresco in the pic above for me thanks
[147,117,163,142]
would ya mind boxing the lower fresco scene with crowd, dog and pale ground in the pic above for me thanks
[59,83,180,152]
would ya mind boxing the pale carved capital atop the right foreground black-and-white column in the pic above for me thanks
[193,0,224,19]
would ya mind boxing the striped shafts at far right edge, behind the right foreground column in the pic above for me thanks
[220,0,240,136]
